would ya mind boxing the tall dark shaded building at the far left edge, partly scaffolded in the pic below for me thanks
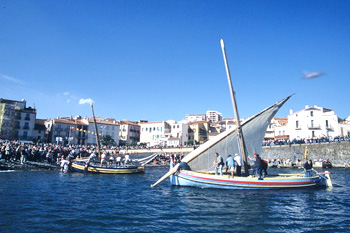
[0,98,36,140]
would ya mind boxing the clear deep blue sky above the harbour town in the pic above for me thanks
[0,0,350,122]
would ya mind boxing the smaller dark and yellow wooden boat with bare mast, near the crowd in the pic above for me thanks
[72,103,145,174]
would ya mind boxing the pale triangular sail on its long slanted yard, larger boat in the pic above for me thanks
[152,95,292,187]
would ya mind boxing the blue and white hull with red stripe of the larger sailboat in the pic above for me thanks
[170,170,328,189]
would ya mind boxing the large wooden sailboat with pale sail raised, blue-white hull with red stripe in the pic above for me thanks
[152,40,332,189]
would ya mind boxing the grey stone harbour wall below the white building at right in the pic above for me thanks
[261,141,350,165]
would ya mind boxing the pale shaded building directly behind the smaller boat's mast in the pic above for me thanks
[84,117,120,145]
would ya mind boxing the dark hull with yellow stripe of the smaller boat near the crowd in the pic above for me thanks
[72,163,145,174]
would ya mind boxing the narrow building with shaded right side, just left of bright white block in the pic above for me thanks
[119,120,141,146]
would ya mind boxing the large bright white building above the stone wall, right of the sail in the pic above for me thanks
[288,105,340,140]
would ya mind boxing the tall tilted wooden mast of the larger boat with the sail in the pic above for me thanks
[220,39,249,175]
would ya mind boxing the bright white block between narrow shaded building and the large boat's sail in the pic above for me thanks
[140,121,171,146]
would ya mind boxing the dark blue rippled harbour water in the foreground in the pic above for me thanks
[0,167,350,232]
